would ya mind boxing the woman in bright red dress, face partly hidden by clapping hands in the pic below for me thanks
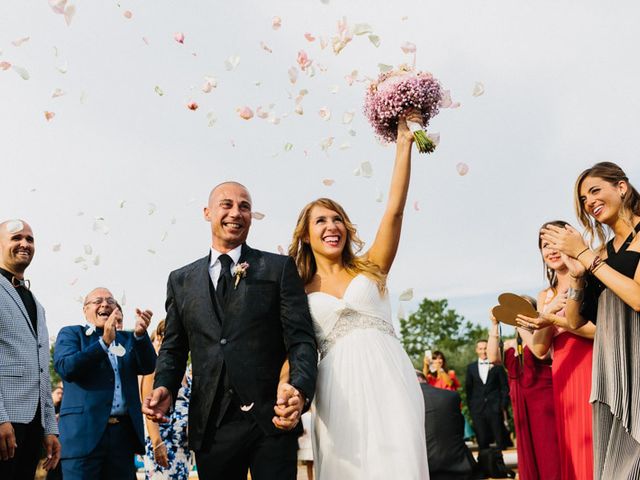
[521,220,595,480]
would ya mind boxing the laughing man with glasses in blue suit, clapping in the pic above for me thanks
[54,288,156,480]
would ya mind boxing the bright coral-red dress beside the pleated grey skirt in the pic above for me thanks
[552,332,593,480]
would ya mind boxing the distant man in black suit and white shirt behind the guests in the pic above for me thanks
[465,340,509,450]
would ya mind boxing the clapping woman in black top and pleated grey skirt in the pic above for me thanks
[542,162,640,480]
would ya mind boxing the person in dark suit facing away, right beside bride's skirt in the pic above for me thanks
[416,370,477,480]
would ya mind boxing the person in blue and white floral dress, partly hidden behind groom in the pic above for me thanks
[140,320,191,480]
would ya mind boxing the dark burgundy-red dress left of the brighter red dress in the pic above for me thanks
[504,346,561,480]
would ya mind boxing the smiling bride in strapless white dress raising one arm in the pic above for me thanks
[289,113,429,480]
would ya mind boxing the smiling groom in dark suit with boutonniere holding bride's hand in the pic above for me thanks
[143,182,317,480]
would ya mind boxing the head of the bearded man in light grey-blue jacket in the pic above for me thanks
[0,219,36,279]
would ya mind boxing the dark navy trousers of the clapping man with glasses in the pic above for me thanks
[62,416,138,480]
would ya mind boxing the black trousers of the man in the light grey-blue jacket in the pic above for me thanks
[0,407,44,480]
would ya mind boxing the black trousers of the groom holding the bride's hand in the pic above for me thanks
[196,402,298,480]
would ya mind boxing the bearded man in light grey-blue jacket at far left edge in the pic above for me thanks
[0,220,60,480]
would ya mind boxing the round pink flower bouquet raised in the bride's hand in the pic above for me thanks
[364,67,443,153]
